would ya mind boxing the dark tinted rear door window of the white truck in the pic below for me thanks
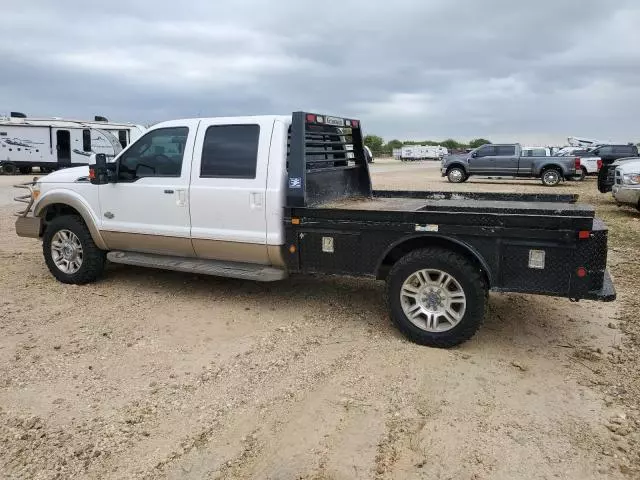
[200,125,260,178]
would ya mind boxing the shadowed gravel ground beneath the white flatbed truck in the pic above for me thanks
[101,265,591,350]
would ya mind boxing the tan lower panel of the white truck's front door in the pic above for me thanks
[100,230,195,257]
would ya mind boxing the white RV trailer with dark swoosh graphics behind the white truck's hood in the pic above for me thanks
[0,112,145,174]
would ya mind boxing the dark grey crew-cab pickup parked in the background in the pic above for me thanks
[441,143,580,186]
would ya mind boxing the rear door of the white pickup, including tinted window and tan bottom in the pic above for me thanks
[190,117,274,265]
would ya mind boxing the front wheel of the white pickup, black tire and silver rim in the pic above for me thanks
[42,215,106,285]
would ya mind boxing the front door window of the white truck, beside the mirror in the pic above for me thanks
[118,127,189,182]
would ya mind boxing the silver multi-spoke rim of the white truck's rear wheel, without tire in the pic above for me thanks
[400,269,467,332]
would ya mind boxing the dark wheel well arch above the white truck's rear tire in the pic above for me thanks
[376,235,492,288]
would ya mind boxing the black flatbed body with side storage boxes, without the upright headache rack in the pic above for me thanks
[288,191,607,298]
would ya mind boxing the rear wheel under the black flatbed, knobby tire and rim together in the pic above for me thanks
[386,248,487,348]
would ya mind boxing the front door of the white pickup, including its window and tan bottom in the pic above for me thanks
[99,120,199,257]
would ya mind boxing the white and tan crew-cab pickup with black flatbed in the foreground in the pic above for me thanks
[16,112,615,347]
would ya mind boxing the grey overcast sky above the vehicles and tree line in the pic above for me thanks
[0,0,640,144]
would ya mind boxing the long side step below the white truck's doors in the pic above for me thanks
[107,251,287,282]
